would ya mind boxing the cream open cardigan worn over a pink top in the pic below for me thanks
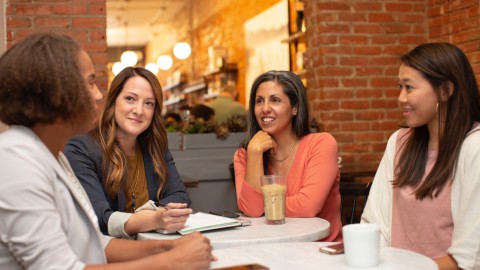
[361,125,480,269]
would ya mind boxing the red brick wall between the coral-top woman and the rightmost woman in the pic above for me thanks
[305,0,428,166]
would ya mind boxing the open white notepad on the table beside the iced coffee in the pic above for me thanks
[177,212,242,235]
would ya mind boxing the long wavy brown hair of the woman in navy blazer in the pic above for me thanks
[92,67,167,199]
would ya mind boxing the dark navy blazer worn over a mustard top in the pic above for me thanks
[64,134,190,234]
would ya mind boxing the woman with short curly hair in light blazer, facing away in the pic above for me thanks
[0,33,212,269]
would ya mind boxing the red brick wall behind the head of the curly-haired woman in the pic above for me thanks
[6,0,107,91]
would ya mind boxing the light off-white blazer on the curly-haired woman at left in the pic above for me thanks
[0,126,111,269]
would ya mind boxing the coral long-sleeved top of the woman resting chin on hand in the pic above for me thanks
[234,133,342,241]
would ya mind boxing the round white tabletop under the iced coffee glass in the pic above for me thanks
[137,217,330,249]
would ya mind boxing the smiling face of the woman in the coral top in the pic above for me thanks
[255,81,297,136]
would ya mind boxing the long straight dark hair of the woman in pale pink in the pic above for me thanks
[393,43,480,199]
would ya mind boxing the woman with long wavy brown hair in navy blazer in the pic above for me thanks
[65,67,192,238]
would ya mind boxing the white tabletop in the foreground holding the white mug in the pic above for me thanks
[210,242,438,270]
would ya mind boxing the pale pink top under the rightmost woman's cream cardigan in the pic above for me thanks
[392,130,453,258]
